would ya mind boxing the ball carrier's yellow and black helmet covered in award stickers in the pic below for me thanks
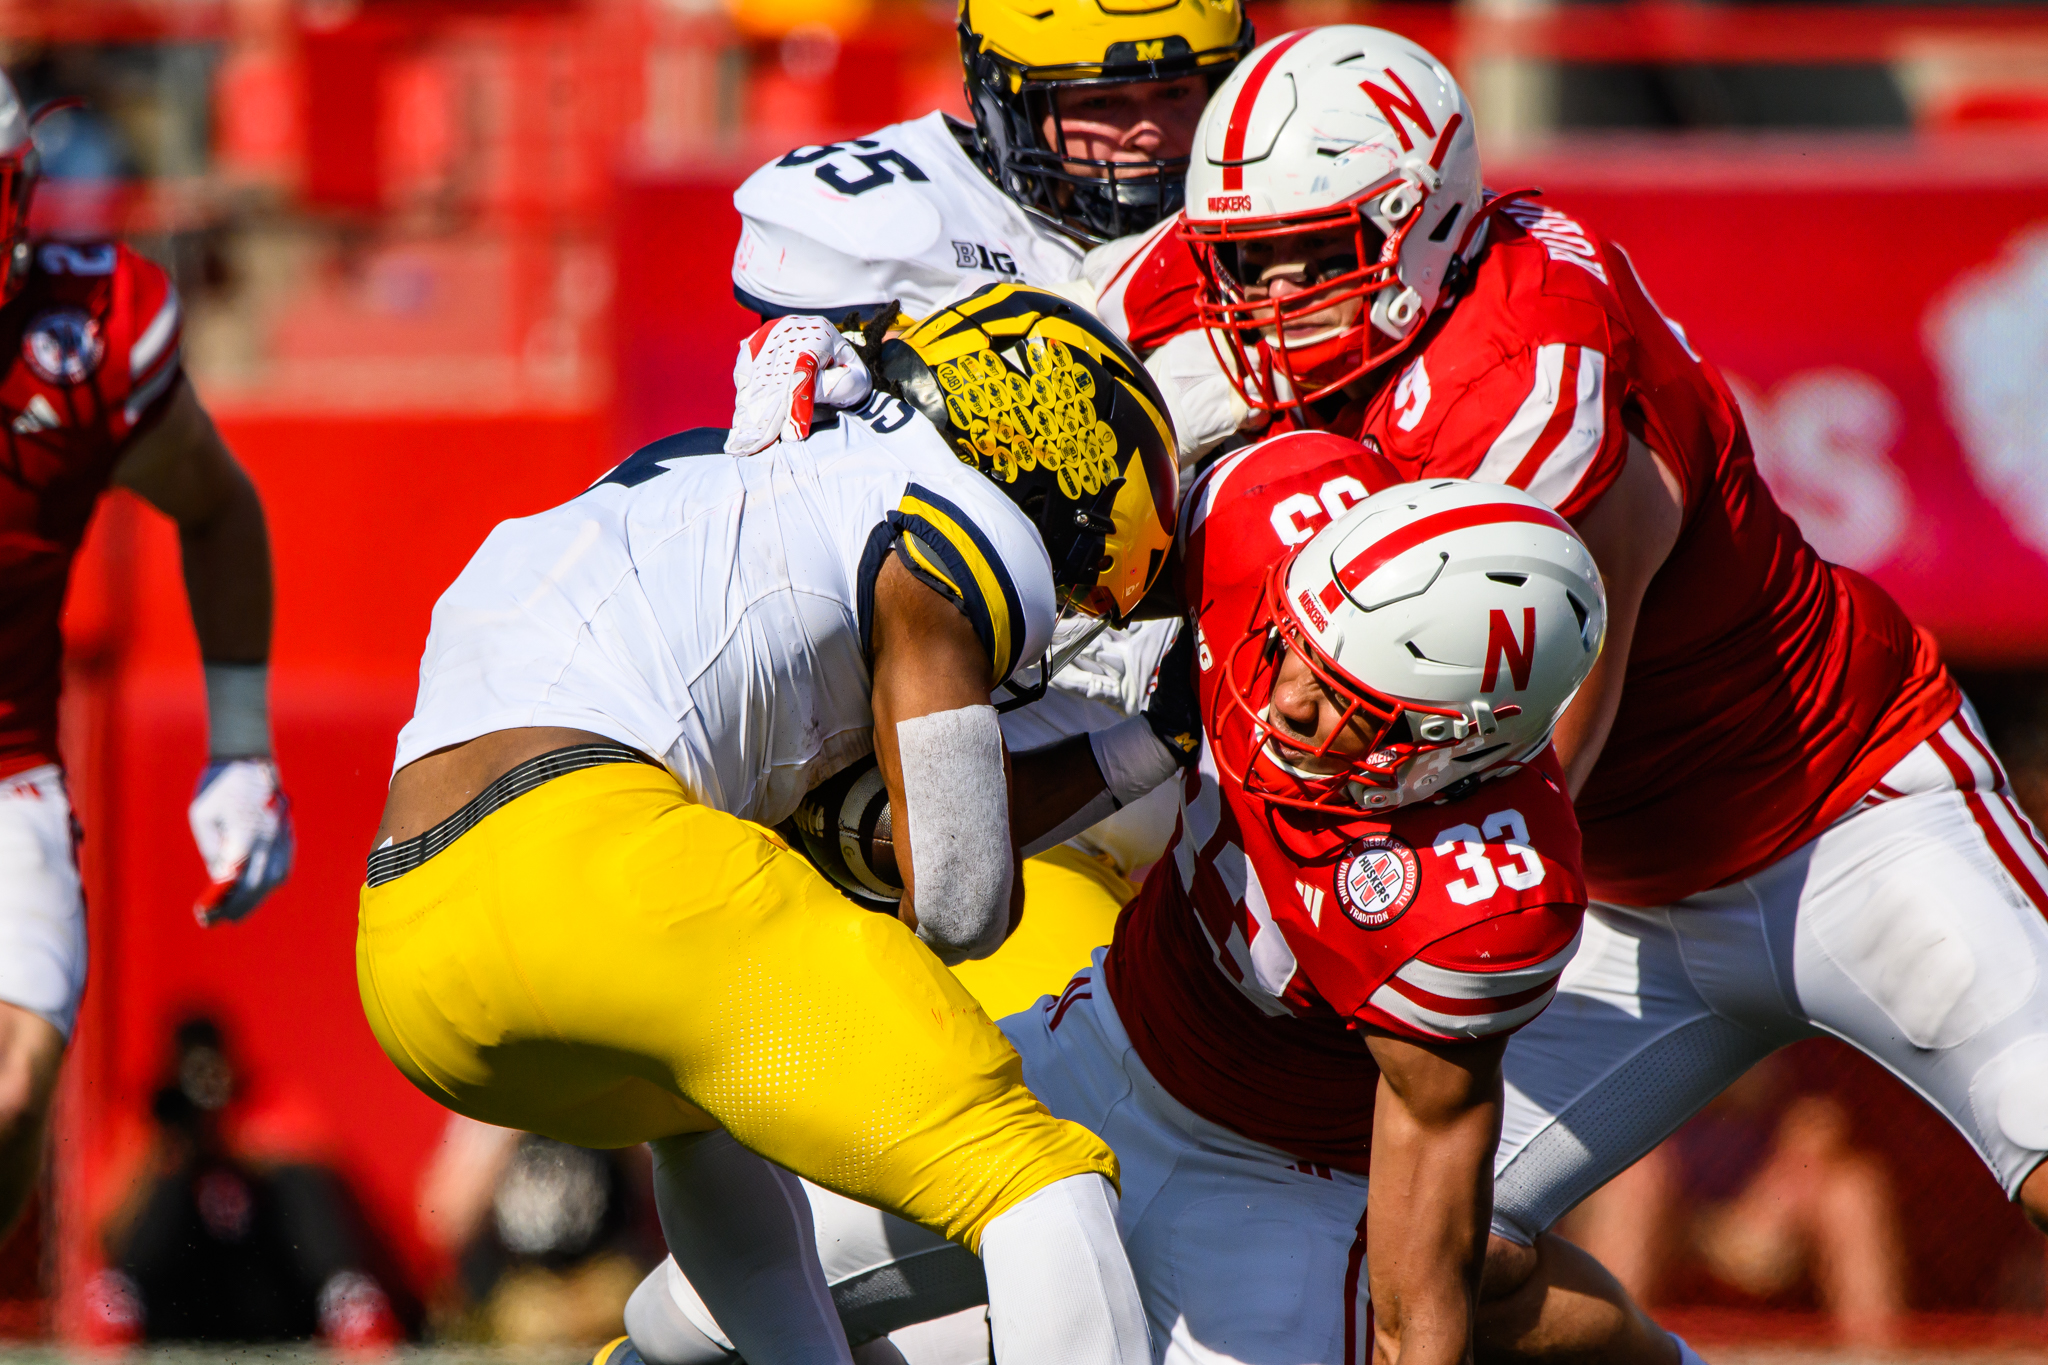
[872,284,1180,624]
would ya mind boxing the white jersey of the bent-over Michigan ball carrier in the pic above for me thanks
[393,395,1057,825]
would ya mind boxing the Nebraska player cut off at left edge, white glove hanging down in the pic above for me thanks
[0,76,291,1236]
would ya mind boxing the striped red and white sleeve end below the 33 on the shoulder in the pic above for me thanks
[1358,905,1585,1040]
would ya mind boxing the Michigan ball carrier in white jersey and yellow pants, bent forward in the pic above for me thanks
[356,287,1188,1365]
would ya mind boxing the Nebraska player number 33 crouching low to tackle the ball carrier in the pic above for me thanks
[1004,446,1606,1363]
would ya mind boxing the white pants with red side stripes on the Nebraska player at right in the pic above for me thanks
[1493,706,2048,1244]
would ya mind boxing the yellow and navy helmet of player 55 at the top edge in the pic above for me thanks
[961,0,1251,244]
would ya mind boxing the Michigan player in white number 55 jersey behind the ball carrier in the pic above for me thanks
[733,0,1251,321]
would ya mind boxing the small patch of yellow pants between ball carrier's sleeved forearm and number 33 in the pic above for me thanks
[952,843,1139,1019]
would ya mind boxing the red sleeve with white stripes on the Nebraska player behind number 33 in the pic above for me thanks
[1430,342,1628,518]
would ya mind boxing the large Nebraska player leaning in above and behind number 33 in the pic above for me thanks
[1104,27,2048,1361]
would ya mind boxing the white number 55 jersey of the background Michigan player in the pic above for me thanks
[733,111,1081,319]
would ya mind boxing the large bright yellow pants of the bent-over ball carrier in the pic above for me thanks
[356,763,1116,1250]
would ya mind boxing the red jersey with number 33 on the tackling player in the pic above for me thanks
[1106,434,1585,1173]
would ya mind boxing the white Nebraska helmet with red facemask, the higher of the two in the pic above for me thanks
[1180,25,1481,409]
